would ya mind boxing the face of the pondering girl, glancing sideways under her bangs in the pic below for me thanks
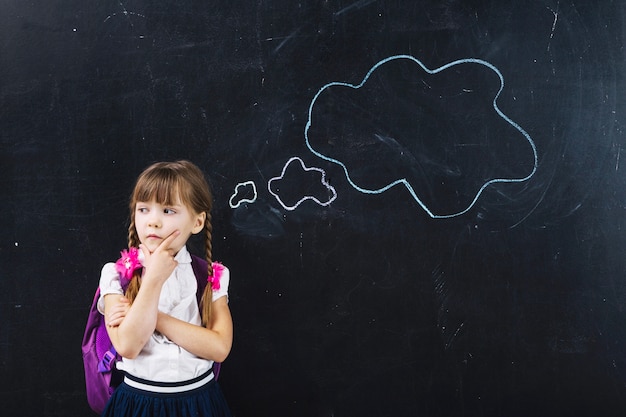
[135,200,206,253]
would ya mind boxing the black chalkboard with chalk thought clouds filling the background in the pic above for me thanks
[0,0,626,417]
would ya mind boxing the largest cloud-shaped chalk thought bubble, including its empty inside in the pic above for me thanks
[305,55,537,218]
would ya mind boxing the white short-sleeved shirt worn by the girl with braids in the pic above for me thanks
[98,247,230,382]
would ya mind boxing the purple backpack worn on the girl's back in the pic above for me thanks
[82,255,220,414]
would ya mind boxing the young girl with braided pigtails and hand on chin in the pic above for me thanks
[98,161,233,417]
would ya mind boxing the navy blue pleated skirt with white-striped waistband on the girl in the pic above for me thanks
[102,368,231,417]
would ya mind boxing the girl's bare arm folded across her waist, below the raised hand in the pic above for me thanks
[156,297,233,362]
